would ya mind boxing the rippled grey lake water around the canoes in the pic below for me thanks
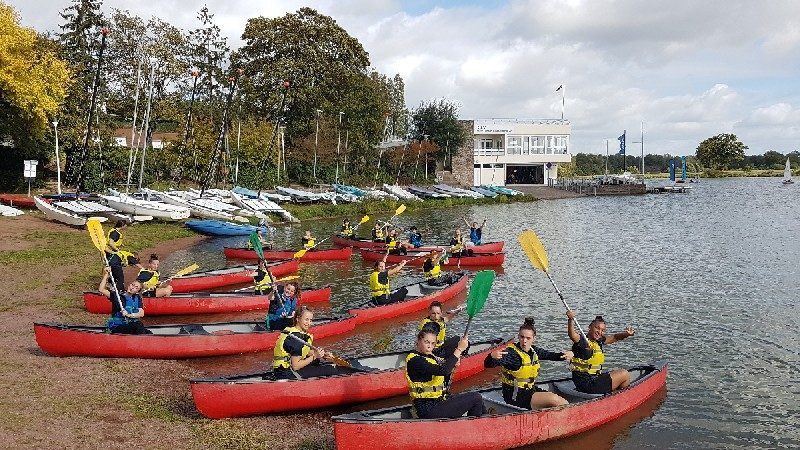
[162,178,800,449]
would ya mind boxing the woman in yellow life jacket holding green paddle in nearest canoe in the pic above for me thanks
[406,328,486,419]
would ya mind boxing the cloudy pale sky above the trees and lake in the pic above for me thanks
[10,0,800,155]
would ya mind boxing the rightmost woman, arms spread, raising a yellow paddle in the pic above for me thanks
[567,310,636,394]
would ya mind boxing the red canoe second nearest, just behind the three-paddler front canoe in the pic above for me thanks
[191,339,503,419]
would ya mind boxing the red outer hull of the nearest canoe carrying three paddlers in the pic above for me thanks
[334,365,667,450]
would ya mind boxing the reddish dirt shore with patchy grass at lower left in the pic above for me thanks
[0,213,333,449]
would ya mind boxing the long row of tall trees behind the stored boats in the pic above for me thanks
[0,0,466,190]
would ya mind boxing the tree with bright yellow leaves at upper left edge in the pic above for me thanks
[0,2,70,137]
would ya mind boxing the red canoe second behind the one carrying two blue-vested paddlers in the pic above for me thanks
[170,259,300,294]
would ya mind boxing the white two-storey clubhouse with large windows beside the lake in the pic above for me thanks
[472,119,572,186]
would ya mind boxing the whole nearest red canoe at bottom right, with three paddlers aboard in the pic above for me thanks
[333,362,667,450]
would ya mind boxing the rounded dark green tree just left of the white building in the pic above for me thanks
[411,99,467,165]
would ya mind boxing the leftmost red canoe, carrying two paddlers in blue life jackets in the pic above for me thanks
[33,317,356,359]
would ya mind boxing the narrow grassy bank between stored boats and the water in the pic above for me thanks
[276,195,536,220]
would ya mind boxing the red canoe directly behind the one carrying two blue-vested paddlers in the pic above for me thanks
[83,286,331,316]
